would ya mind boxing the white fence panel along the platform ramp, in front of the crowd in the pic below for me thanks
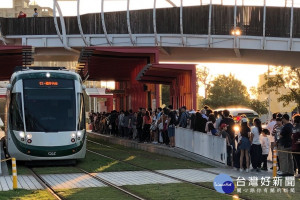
[175,128,227,165]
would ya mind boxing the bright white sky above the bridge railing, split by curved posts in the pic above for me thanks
[0,0,300,13]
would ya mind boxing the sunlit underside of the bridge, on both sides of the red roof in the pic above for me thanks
[34,47,300,67]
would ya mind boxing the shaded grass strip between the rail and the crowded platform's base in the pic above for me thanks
[87,138,211,170]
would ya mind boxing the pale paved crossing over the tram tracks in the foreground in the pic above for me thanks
[0,168,272,191]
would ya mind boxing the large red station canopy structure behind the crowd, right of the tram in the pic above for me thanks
[77,47,197,111]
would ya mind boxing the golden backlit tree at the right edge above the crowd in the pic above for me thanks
[259,66,300,112]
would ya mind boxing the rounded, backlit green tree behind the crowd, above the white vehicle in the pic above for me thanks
[205,74,250,108]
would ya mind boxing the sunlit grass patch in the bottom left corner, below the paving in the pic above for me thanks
[0,189,55,200]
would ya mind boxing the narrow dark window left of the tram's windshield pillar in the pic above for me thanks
[10,93,24,131]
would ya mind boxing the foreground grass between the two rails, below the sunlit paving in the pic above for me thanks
[57,187,134,200]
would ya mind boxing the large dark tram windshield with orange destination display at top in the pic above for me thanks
[23,79,76,132]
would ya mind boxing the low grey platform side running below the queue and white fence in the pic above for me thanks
[88,132,227,168]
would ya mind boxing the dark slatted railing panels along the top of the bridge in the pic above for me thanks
[0,5,300,38]
